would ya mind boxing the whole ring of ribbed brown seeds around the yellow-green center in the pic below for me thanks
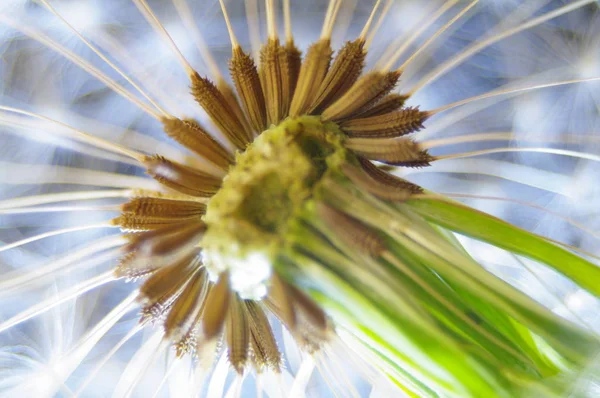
[114,2,432,373]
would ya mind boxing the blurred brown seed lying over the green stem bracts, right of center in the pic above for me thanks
[317,203,386,257]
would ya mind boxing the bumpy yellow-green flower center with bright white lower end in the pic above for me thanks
[202,116,353,299]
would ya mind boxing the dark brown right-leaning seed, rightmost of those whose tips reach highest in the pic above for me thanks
[310,39,367,114]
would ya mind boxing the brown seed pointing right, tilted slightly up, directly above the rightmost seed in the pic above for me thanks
[340,108,427,138]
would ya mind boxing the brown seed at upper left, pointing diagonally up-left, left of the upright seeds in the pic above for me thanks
[191,73,250,150]
